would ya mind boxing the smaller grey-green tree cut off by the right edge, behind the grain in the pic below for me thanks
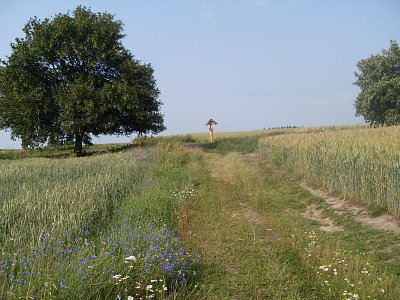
[355,41,400,125]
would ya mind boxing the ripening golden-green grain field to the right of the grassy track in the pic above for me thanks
[260,126,400,215]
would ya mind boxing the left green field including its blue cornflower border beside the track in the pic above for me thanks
[0,146,197,299]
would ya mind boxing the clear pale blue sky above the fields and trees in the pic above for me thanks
[0,0,400,148]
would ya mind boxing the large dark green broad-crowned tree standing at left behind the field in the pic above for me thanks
[0,6,165,155]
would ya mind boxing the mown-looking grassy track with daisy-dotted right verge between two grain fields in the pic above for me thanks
[178,150,400,300]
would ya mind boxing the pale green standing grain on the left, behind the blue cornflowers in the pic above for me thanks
[0,153,135,246]
